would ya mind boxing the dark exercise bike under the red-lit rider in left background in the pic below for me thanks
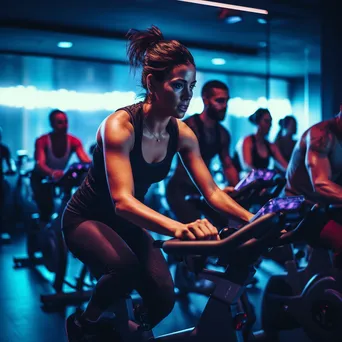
[13,163,95,309]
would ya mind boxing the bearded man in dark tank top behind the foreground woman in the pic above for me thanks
[166,81,239,222]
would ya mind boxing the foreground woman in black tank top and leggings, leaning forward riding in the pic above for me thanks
[63,26,252,342]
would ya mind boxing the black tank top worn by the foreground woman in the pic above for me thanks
[67,102,178,216]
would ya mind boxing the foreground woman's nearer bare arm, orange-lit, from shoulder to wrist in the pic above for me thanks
[100,111,182,237]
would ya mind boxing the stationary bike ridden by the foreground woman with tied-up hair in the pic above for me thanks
[71,195,306,342]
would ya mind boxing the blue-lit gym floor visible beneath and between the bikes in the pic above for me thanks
[0,234,310,342]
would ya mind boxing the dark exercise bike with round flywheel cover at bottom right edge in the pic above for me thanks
[260,205,342,342]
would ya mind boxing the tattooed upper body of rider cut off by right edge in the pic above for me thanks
[286,116,342,203]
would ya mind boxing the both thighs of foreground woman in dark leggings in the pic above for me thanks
[64,220,173,293]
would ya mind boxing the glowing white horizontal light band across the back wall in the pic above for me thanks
[0,86,292,118]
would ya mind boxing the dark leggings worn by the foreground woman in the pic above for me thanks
[63,211,175,326]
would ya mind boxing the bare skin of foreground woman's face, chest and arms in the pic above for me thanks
[97,65,253,239]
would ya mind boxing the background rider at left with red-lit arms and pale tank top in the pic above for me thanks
[31,109,91,225]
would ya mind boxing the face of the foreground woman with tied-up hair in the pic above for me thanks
[153,64,196,119]
